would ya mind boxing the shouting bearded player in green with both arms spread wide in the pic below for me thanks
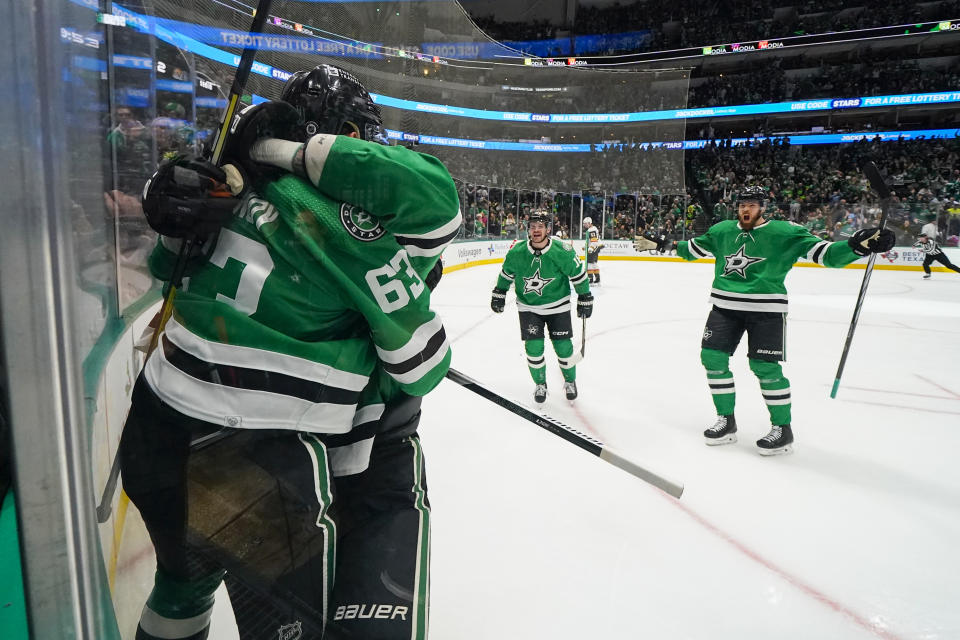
[660,187,895,455]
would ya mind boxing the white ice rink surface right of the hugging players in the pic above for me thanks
[420,261,960,640]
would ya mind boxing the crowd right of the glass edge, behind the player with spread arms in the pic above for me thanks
[687,138,960,243]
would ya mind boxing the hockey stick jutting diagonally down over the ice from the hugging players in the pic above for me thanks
[447,369,683,498]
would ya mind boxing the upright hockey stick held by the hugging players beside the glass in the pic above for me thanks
[144,0,273,362]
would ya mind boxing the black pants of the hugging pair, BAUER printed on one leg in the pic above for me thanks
[120,377,430,640]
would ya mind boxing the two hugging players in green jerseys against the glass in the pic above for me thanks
[120,65,461,640]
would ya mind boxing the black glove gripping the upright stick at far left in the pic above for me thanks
[141,156,239,238]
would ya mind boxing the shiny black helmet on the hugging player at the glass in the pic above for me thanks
[280,64,387,144]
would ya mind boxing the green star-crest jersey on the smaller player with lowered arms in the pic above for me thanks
[497,238,590,315]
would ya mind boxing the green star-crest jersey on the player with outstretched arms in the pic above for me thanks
[677,220,859,313]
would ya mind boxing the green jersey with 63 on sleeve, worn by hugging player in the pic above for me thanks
[145,136,461,434]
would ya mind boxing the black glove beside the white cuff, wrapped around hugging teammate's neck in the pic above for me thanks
[221,100,303,193]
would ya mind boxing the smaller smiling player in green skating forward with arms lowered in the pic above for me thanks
[490,212,593,402]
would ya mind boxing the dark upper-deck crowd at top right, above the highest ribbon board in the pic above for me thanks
[473,0,960,55]
